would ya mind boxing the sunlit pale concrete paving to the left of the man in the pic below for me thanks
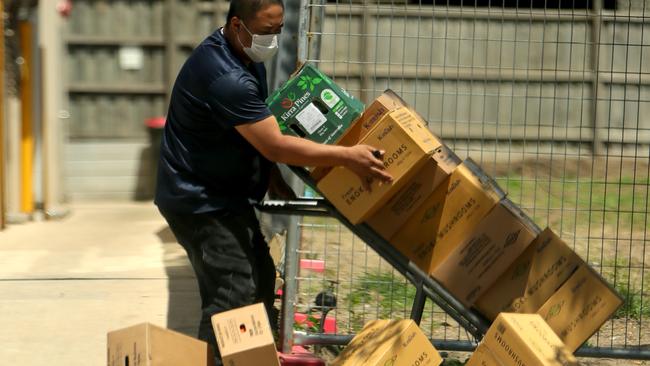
[0,202,199,366]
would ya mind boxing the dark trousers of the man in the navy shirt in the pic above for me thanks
[160,207,277,365]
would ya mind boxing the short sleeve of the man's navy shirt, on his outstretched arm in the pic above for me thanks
[208,72,271,126]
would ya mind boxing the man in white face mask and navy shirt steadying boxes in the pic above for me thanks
[155,0,392,365]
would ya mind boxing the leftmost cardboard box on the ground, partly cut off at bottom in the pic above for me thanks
[106,323,214,366]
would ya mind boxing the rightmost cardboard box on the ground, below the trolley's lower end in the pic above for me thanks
[466,313,578,366]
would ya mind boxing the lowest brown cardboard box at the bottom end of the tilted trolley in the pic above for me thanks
[538,265,623,351]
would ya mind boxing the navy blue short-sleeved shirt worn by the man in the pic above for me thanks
[155,29,271,213]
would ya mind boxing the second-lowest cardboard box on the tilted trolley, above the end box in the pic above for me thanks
[474,228,584,320]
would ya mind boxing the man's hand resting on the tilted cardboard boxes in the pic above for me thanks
[345,145,393,190]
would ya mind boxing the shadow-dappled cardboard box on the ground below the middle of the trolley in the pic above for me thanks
[331,320,442,366]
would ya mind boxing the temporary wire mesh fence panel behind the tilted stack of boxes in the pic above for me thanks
[284,0,650,360]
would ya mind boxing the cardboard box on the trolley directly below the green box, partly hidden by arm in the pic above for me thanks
[311,89,426,182]
